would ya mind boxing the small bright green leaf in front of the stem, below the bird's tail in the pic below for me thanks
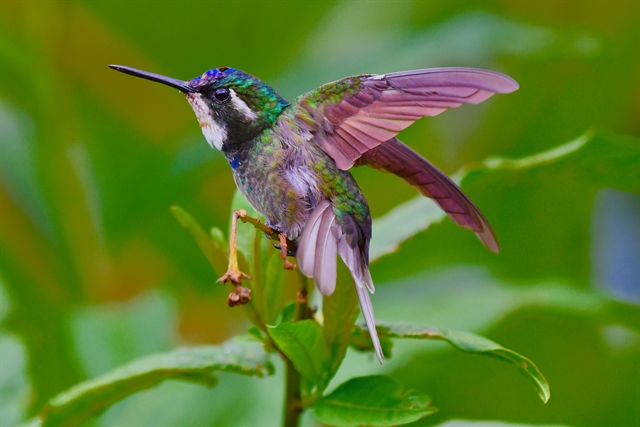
[269,320,329,389]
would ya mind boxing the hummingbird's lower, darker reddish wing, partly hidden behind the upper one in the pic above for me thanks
[356,138,500,253]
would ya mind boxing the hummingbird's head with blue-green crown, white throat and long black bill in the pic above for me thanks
[110,65,289,152]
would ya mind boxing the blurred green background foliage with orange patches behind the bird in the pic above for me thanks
[0,0,640,426]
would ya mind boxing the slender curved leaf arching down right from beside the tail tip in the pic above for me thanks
[353,323,551,403]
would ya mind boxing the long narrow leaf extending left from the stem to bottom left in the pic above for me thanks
[40,338,273,426]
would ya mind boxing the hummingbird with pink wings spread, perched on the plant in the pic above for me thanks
[110,65,519,363]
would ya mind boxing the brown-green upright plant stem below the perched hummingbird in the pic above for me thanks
[283,270,312,427]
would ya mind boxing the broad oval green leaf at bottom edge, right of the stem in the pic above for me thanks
[314,375,437,426]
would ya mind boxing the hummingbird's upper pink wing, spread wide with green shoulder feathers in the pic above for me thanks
[294,68,518,170]
